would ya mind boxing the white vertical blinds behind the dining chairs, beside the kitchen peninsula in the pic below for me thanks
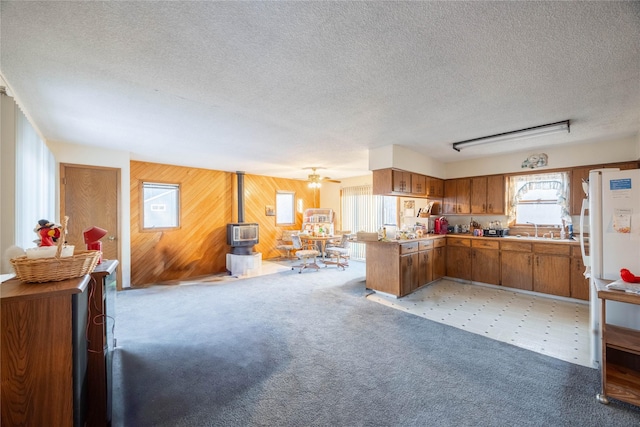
[341,185,396,260]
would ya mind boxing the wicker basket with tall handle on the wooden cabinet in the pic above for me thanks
[10,217,100,283]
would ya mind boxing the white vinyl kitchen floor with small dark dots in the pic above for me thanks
[367,279,592,367]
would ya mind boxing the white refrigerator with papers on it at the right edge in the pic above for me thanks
[580,169,640,367]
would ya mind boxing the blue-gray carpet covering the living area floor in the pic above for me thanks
[113,262,640,427]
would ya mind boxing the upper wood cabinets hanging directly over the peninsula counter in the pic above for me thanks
[373,168,443,198]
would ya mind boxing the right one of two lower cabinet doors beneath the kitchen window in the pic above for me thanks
[533,254,571,297]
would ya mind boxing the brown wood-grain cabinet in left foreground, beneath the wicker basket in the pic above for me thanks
[0,275,89,426]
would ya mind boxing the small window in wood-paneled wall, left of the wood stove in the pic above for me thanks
[142,182,180,230]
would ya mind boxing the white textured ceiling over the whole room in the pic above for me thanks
[0,1,640,178]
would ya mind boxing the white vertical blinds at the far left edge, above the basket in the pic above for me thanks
[15,109,57,249]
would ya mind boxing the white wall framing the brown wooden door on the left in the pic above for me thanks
[47,142,131,288]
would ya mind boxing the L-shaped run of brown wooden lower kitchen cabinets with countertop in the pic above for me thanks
[366,234,589,300]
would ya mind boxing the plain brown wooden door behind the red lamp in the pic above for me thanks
[60,163,122,289]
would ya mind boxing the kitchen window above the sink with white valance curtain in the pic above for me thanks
[509,172,571,226]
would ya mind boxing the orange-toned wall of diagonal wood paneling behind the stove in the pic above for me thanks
[131,161,318,287]
